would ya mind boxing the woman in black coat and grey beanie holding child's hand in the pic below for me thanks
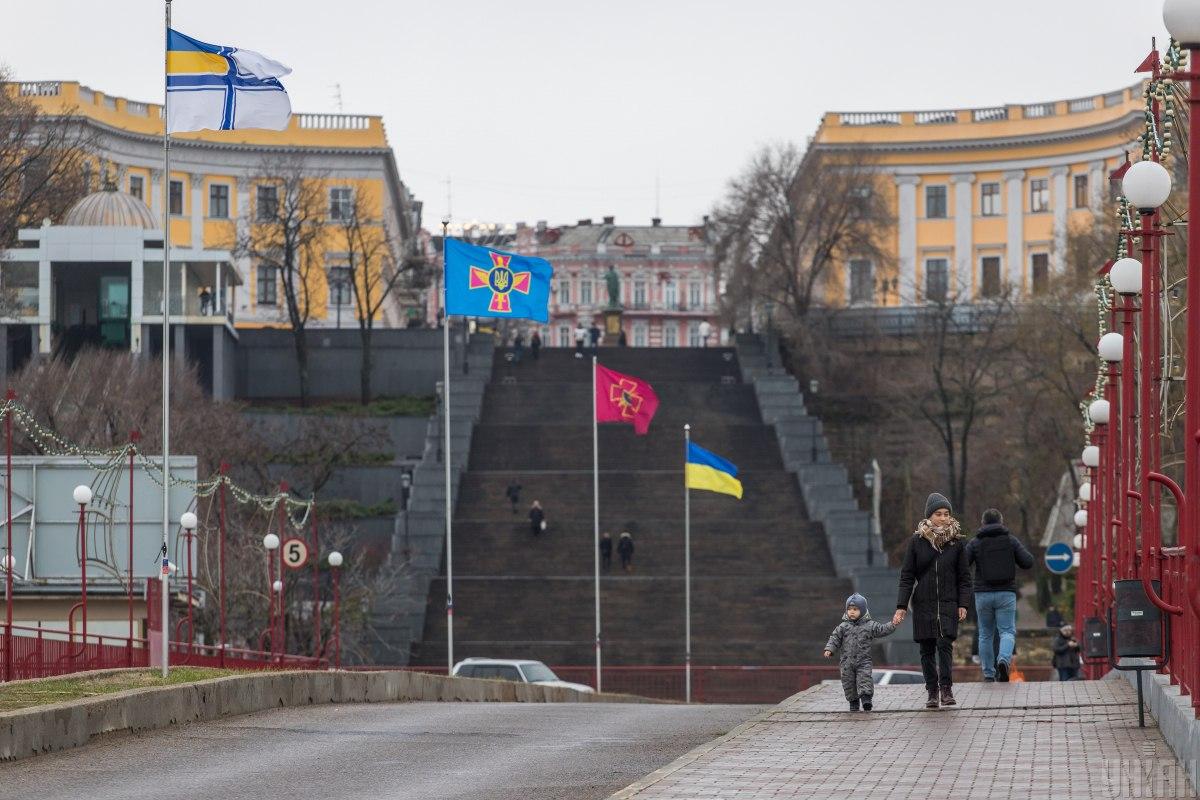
[892,492,971,709]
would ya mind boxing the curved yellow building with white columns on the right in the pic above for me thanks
[810,83,1144,306]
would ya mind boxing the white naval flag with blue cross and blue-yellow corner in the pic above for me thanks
[167,29,292,133]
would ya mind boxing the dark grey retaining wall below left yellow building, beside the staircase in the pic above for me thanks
[238,329,487,399]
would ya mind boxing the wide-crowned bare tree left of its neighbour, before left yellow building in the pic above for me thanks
[233,156,329,405]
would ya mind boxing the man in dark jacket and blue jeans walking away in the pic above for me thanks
[967,509,1033,684]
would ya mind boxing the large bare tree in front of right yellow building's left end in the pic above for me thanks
[712,143,894,320]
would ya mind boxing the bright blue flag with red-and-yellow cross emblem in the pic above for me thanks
[444,239,554,323]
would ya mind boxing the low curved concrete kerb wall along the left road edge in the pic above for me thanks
[0,670,656,760]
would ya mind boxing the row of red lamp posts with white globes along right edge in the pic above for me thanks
[1074,0,1200,696]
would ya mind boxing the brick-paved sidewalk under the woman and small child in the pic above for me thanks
[612,680,1195,800]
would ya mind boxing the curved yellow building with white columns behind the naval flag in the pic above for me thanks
[0,82,424,331]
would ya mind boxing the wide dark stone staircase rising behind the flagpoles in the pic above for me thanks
[410,348,851,666]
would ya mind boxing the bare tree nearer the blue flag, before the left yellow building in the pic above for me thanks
[340,192,430,405]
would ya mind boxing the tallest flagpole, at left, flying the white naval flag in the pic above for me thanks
[159,0,172,678]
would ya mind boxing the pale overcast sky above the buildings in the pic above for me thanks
[0,0,1165,228]
